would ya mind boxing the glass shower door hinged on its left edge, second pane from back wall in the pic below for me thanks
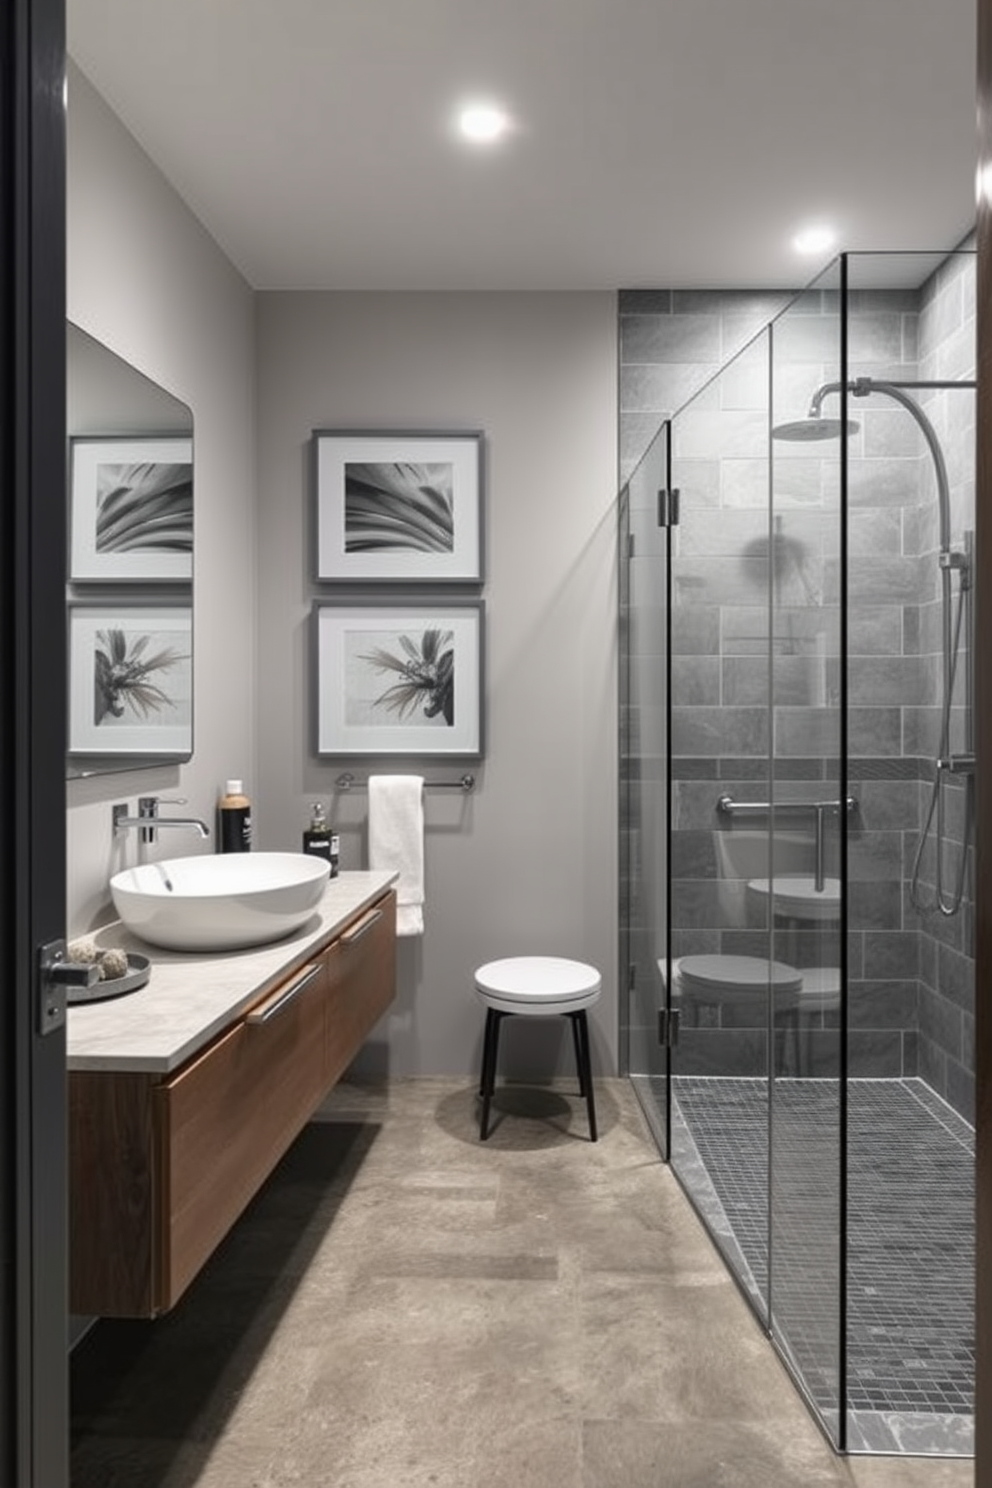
[668,325,776,1321]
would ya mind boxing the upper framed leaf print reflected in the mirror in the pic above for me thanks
[68,436,193,582]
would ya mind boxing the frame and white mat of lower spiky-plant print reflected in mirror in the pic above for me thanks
[68,604,193,754]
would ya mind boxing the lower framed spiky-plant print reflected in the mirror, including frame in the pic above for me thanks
[68,601,193,757]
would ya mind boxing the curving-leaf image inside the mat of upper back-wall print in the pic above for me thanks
[345,460,455,554]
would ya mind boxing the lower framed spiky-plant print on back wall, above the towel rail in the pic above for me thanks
[314,600,483,759]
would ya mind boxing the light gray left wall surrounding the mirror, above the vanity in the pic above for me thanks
[67,68,254,933]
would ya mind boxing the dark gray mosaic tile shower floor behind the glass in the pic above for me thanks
[654,1077,974,1454]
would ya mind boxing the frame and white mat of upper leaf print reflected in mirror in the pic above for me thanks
[70,439,193,580]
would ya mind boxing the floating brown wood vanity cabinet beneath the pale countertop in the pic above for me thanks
[68,891,396,1317]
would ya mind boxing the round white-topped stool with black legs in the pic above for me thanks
[476,955,602,1141]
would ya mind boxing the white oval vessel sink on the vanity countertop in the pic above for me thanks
[110,853,330,951]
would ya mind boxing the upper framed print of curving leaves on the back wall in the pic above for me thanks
[314,429,483,583]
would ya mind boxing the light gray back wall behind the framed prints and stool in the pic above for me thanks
[254,293,617,1074]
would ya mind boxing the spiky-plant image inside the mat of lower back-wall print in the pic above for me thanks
[345,626,455,728]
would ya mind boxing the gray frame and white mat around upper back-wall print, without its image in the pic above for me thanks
[315,433,482,582]
